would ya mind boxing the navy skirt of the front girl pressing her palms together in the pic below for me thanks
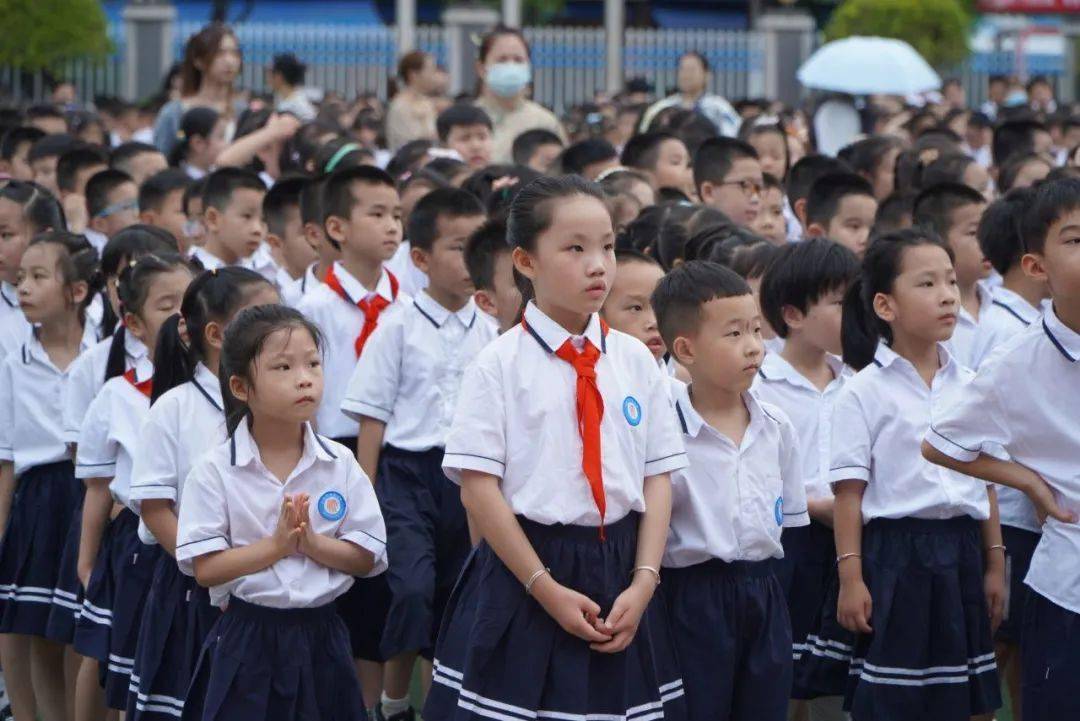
[180,598,367,721]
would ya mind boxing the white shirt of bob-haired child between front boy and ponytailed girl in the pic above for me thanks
[753,353,854,500]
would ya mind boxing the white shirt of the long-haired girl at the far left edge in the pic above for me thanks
[0,334,90,477]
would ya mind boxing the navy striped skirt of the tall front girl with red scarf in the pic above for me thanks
[423,514,686,721]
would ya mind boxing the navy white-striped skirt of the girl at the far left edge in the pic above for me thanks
[0,461,85,640]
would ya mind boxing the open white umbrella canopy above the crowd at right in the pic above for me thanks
[797,37,942,95]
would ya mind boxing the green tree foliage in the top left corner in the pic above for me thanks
[0,0,111,71]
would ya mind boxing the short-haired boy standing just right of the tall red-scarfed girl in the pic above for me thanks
[652,260,809,721]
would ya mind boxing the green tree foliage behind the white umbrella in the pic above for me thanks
[825,0,971,68]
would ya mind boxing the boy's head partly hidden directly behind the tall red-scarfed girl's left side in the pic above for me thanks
[465,218,522,334]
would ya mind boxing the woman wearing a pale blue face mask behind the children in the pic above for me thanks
[476,26,566,163]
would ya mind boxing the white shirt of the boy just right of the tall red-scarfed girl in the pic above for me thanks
[663,379,810,568]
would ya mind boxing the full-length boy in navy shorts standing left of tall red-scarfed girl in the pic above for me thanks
[341,188,496,721]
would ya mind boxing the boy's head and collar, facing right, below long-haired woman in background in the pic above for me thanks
[191,167,266,271]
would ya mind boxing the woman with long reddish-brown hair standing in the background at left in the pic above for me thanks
[153,23,243,157]
